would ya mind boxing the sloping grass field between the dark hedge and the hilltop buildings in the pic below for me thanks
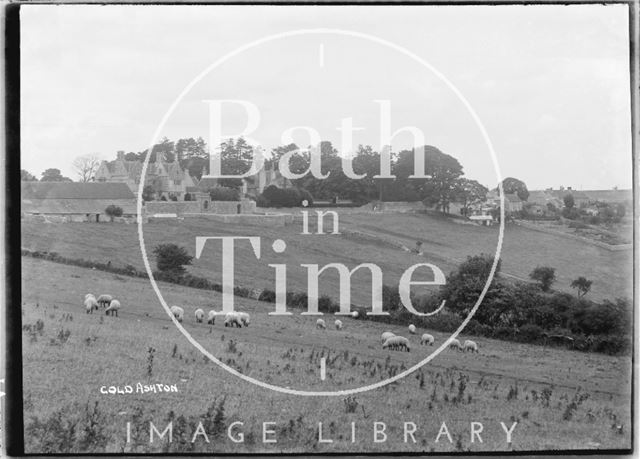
[22,210,632,305]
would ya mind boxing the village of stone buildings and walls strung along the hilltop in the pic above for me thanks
[21,147,632,230]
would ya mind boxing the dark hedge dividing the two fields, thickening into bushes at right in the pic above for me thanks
[22,249,632,355]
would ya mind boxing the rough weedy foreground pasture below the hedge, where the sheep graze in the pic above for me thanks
[21,258,631,453]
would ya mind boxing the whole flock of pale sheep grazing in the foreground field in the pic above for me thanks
[84,293,478,352]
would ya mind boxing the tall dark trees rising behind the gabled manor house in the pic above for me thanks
[125,137,488,211]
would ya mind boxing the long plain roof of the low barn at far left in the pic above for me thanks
[20,182,135,200]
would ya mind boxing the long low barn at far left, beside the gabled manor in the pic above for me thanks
[20,182,136,222]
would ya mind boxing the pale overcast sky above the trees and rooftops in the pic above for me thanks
[21,5,631,189]
